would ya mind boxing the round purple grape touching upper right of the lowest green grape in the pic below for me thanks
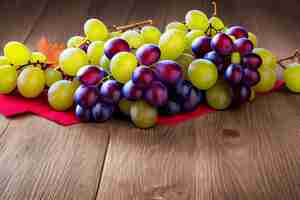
[144,81,169,107]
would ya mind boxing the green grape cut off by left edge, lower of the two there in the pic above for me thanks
[0,65,17,94]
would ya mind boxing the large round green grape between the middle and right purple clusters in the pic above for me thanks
[188,59,218,90]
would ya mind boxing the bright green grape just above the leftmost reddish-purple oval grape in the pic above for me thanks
[59,48,88,76]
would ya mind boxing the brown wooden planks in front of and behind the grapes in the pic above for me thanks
[0,0,300,200]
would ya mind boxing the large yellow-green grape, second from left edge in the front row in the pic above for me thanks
[17,67,46,98]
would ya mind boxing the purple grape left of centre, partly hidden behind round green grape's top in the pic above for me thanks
[104,38,131,59]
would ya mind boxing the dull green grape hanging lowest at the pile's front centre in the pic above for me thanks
[130,101,158,129]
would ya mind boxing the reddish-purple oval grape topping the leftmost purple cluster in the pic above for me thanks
[77,65,107,86]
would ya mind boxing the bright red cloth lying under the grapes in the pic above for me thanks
[0,81,284,126]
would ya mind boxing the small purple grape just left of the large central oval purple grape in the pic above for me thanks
[132,66,155,88]
